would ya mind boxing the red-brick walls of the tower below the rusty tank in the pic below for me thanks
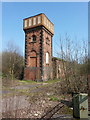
[24,26,52,81]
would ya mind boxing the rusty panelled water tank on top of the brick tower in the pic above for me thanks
[23,13,54,34]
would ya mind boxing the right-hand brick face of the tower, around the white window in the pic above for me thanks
[43,29,52,80]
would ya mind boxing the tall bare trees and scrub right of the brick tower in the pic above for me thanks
[57,34,87,92]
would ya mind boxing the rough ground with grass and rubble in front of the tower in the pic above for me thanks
[2,79,78,118]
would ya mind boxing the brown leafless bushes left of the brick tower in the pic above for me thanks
[2,44,24,79]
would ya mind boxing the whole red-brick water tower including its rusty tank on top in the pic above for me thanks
[23,13,54,81]
